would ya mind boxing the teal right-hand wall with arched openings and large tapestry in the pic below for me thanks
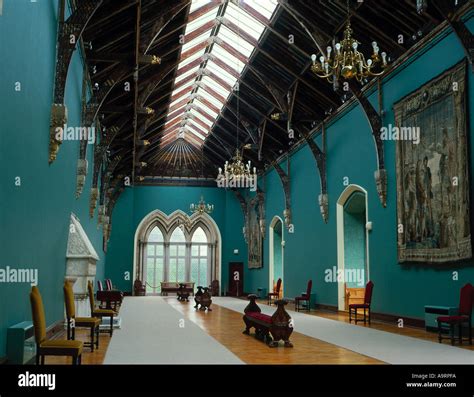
[247,19,474,318]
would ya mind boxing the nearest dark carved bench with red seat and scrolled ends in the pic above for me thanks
[243,295,293,347]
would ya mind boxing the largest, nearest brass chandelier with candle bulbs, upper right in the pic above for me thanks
[311,1,387,83]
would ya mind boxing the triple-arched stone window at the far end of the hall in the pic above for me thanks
[133,210,221,295]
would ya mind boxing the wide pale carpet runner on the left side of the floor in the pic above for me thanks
[104,296,243,364]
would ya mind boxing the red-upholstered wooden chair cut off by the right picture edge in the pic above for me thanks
[436,283,474,345]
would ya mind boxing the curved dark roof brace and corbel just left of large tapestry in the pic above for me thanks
[349,82,387,207]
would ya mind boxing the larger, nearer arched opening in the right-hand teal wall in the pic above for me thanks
[337,185,370,311]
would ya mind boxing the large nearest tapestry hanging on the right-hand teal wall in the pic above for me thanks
[394,62,472,263]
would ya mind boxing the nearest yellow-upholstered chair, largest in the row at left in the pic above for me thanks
[30,286,83,365]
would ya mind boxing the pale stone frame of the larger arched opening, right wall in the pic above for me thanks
[336,184,370,311]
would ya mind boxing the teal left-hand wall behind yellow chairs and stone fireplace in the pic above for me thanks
[0,0,105,357]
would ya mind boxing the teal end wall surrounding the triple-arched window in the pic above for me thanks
[106,186,247,291]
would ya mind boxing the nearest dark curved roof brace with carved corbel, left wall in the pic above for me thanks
[49,0,103,164]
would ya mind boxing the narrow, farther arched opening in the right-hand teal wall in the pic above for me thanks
[268,216,285,296]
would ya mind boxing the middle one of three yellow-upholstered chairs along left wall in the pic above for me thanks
[63,280,100,352]
